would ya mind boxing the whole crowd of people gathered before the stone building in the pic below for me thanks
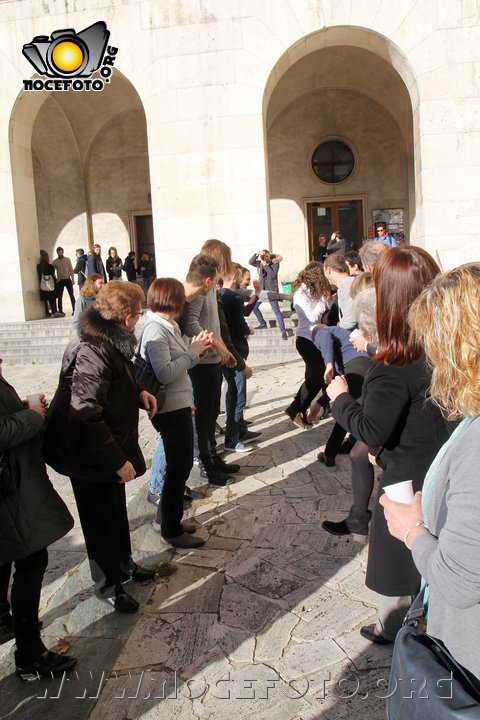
[0,232,480,704]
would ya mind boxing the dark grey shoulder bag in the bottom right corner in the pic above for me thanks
[386,590,480,720]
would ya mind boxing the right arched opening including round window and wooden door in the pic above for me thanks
[264,27,416,271]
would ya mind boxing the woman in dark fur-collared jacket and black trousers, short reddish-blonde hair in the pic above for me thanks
[45,282,156,613]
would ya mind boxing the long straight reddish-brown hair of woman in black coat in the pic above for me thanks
[373,245,440,365]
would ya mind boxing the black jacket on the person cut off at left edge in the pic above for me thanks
[0,376,73,565]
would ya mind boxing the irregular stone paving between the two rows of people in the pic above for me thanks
[0,357,391,720]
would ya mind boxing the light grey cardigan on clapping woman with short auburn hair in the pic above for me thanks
[139,312,199,414]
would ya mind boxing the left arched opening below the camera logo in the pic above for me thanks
[10,69,152,320]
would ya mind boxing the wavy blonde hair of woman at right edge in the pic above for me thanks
[408,263,480,420]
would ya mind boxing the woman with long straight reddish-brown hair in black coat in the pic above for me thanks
[327,246,448,644]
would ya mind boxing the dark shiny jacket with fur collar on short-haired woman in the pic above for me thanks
[44,307,146,482]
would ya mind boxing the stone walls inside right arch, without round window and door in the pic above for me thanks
[263,26,421,276]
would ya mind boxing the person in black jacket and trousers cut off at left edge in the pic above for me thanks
[0,361,76,680]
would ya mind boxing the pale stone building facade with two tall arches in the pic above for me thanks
[0,0,480,321]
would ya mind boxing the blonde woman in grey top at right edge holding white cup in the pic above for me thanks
[380,263,480,678]
